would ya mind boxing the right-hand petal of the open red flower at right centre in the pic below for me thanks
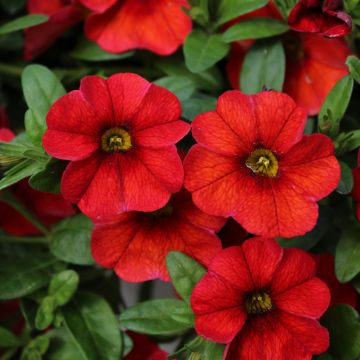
[280,134,341,200]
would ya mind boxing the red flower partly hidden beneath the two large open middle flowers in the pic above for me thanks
[91,191,225,282]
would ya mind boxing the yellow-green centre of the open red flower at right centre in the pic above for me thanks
[245,149,279,177]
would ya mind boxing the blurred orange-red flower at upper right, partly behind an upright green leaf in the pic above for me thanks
[227,5,351,115]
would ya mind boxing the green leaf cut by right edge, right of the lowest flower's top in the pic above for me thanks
[335,225,360,283]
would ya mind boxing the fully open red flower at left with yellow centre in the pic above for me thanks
[43,73,189,219]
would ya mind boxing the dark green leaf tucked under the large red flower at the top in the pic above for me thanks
[71,39,135,61]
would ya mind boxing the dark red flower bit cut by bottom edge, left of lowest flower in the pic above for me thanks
[124,331,168,360]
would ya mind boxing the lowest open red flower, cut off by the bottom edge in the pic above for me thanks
[191,237,330,360]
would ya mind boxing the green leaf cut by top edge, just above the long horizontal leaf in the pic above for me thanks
[217,0,269,25]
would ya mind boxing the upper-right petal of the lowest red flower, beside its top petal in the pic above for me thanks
[271,249,316,295]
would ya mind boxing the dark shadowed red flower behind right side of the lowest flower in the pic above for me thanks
[314,254,357,307]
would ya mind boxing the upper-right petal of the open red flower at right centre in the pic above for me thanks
[253,91,306,154]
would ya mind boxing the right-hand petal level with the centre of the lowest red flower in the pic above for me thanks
[272,278,330,319]
